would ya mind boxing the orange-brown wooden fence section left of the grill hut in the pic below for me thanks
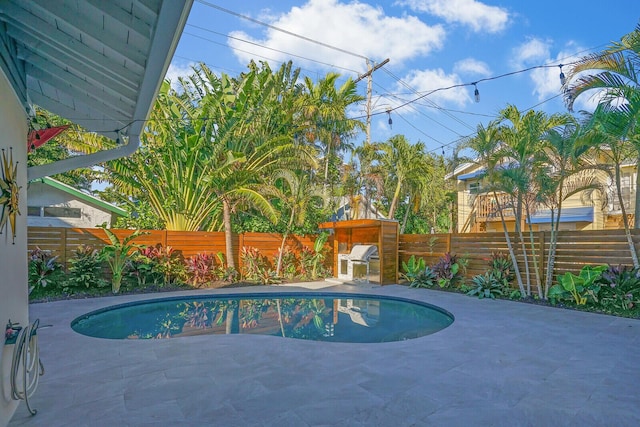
[28,227,324,269]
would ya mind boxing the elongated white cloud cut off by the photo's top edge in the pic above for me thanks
[396,0,509,33]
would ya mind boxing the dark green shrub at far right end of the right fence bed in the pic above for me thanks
[598,265,640,312]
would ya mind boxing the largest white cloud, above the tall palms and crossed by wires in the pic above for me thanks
[229,0,445,73]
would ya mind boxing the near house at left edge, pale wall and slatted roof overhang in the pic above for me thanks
[0,0,193,426]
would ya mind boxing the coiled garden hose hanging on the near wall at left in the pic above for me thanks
[11,319,44,415]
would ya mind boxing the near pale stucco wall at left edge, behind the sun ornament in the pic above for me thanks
[0,71,29,426]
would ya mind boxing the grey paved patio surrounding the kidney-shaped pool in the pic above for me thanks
[9,282,640,427]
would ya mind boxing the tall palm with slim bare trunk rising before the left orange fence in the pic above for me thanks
[192,63,313,267]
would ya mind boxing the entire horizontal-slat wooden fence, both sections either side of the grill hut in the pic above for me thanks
[28,227,640,290]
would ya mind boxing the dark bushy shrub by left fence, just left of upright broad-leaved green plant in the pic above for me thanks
[62,245,109,292]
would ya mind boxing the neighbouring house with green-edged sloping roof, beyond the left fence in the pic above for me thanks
[27,177,127,228]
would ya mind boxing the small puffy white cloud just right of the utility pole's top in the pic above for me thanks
[397,69,471,107]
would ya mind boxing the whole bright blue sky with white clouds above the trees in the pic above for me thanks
[167,0,640,156]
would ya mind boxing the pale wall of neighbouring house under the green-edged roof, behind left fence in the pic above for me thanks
[28,182,111,228]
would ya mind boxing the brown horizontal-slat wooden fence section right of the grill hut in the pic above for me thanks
[398,230,640,292]
